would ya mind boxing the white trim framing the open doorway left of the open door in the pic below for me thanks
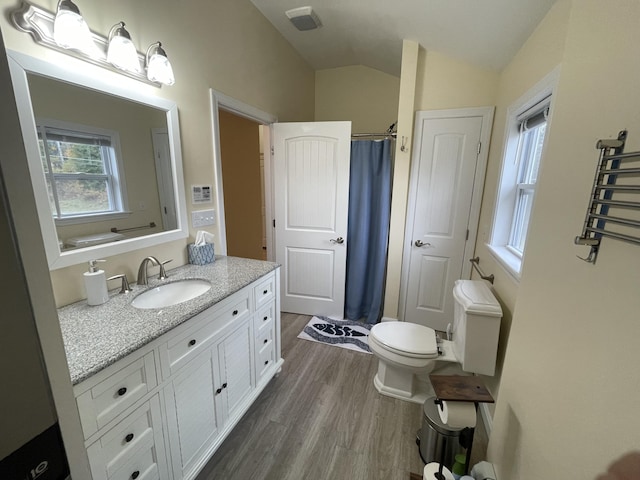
[209,88,278,261]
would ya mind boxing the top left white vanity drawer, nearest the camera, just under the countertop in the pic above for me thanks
[76,352,157,438]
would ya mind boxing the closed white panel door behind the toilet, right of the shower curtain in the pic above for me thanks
[403,112,487,330]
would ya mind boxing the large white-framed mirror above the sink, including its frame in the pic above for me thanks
[9,52,188,270]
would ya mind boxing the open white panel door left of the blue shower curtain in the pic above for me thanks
[272,122,351,318]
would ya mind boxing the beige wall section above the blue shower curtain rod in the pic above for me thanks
[315,65,400,133]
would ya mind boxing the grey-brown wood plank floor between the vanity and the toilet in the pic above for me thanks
[196,313,486,480]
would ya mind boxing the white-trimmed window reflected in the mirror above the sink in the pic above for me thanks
[37,121,126,224]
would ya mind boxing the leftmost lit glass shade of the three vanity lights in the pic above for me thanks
[53,0,100,58]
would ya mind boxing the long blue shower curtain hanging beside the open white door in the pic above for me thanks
[344,139,392,323]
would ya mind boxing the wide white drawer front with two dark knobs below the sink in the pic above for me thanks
[162,292,249,378]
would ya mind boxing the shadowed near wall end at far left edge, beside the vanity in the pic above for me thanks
[0,30,90,478]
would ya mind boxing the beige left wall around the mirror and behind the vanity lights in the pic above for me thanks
[0,0,315,305]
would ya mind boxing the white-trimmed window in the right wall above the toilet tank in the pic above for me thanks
[487,72,557,278]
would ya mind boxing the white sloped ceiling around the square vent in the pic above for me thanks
[251,0,556,76]
